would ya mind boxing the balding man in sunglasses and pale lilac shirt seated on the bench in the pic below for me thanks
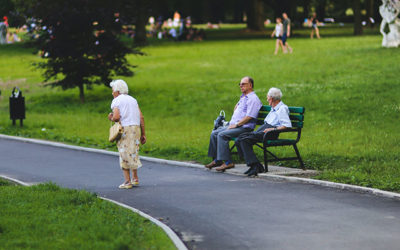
[205,76,262,172]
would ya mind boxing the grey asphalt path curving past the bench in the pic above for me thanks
[0,139,400,250]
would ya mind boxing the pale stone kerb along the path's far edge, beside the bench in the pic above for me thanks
[0,134,400,200]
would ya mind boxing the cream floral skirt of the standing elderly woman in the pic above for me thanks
[117,126,142,169]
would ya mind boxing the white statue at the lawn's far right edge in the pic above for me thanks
[379,0,400,48]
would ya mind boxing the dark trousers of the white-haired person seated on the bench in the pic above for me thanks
[236,123,278,166]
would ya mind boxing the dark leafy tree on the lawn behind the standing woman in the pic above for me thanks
[16,0,140,102]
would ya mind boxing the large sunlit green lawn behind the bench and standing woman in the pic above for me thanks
[0,26,400,191]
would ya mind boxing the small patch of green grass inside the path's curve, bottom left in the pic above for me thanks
[0,179,175,249]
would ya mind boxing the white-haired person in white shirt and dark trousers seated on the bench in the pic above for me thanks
[236,88,292,176]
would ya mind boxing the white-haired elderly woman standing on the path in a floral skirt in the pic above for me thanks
[108,80,146,188]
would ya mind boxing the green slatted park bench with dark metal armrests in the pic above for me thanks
[231,105,305,172]
